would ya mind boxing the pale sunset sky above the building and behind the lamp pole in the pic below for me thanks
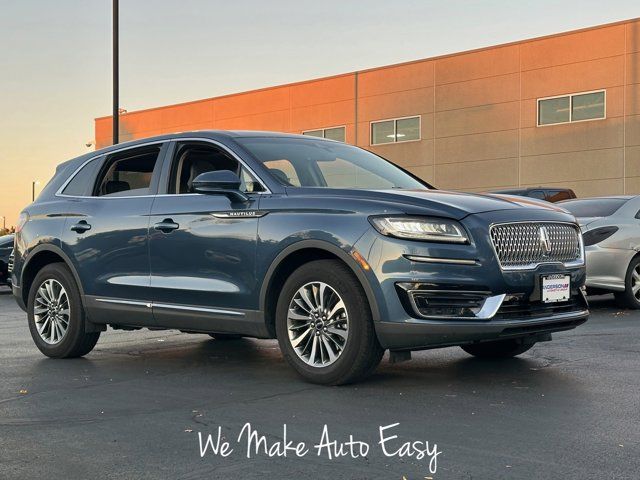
[0,0,640,227]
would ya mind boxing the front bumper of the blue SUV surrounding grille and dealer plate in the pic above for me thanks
[355,211,589,350]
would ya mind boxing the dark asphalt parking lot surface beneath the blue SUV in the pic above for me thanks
[0,289,640,480]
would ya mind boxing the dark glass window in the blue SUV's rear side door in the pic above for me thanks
[93,145,160,197]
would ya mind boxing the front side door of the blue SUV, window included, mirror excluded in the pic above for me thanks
[149,142,262,333]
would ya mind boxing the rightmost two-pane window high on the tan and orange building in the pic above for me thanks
[538,90,606,126]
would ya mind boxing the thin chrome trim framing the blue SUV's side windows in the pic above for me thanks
[55,137,272,200]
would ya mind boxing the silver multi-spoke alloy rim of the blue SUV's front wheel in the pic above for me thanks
[287,282,349,367]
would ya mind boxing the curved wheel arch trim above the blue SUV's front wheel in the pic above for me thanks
[260,240,380,337]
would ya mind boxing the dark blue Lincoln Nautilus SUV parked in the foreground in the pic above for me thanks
[12,131,588,385]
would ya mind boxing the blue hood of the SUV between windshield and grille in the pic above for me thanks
[287,188,567,220]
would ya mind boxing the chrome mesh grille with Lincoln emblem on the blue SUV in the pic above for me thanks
[491,222,582,270]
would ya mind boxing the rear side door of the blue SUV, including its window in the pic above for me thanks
[61,142,168,325]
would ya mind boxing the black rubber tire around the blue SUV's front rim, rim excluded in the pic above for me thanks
[276,261,371,383]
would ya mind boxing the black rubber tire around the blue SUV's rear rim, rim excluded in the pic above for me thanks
[27,263,84,358]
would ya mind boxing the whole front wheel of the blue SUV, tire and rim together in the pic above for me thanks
[276,260,384,385]
